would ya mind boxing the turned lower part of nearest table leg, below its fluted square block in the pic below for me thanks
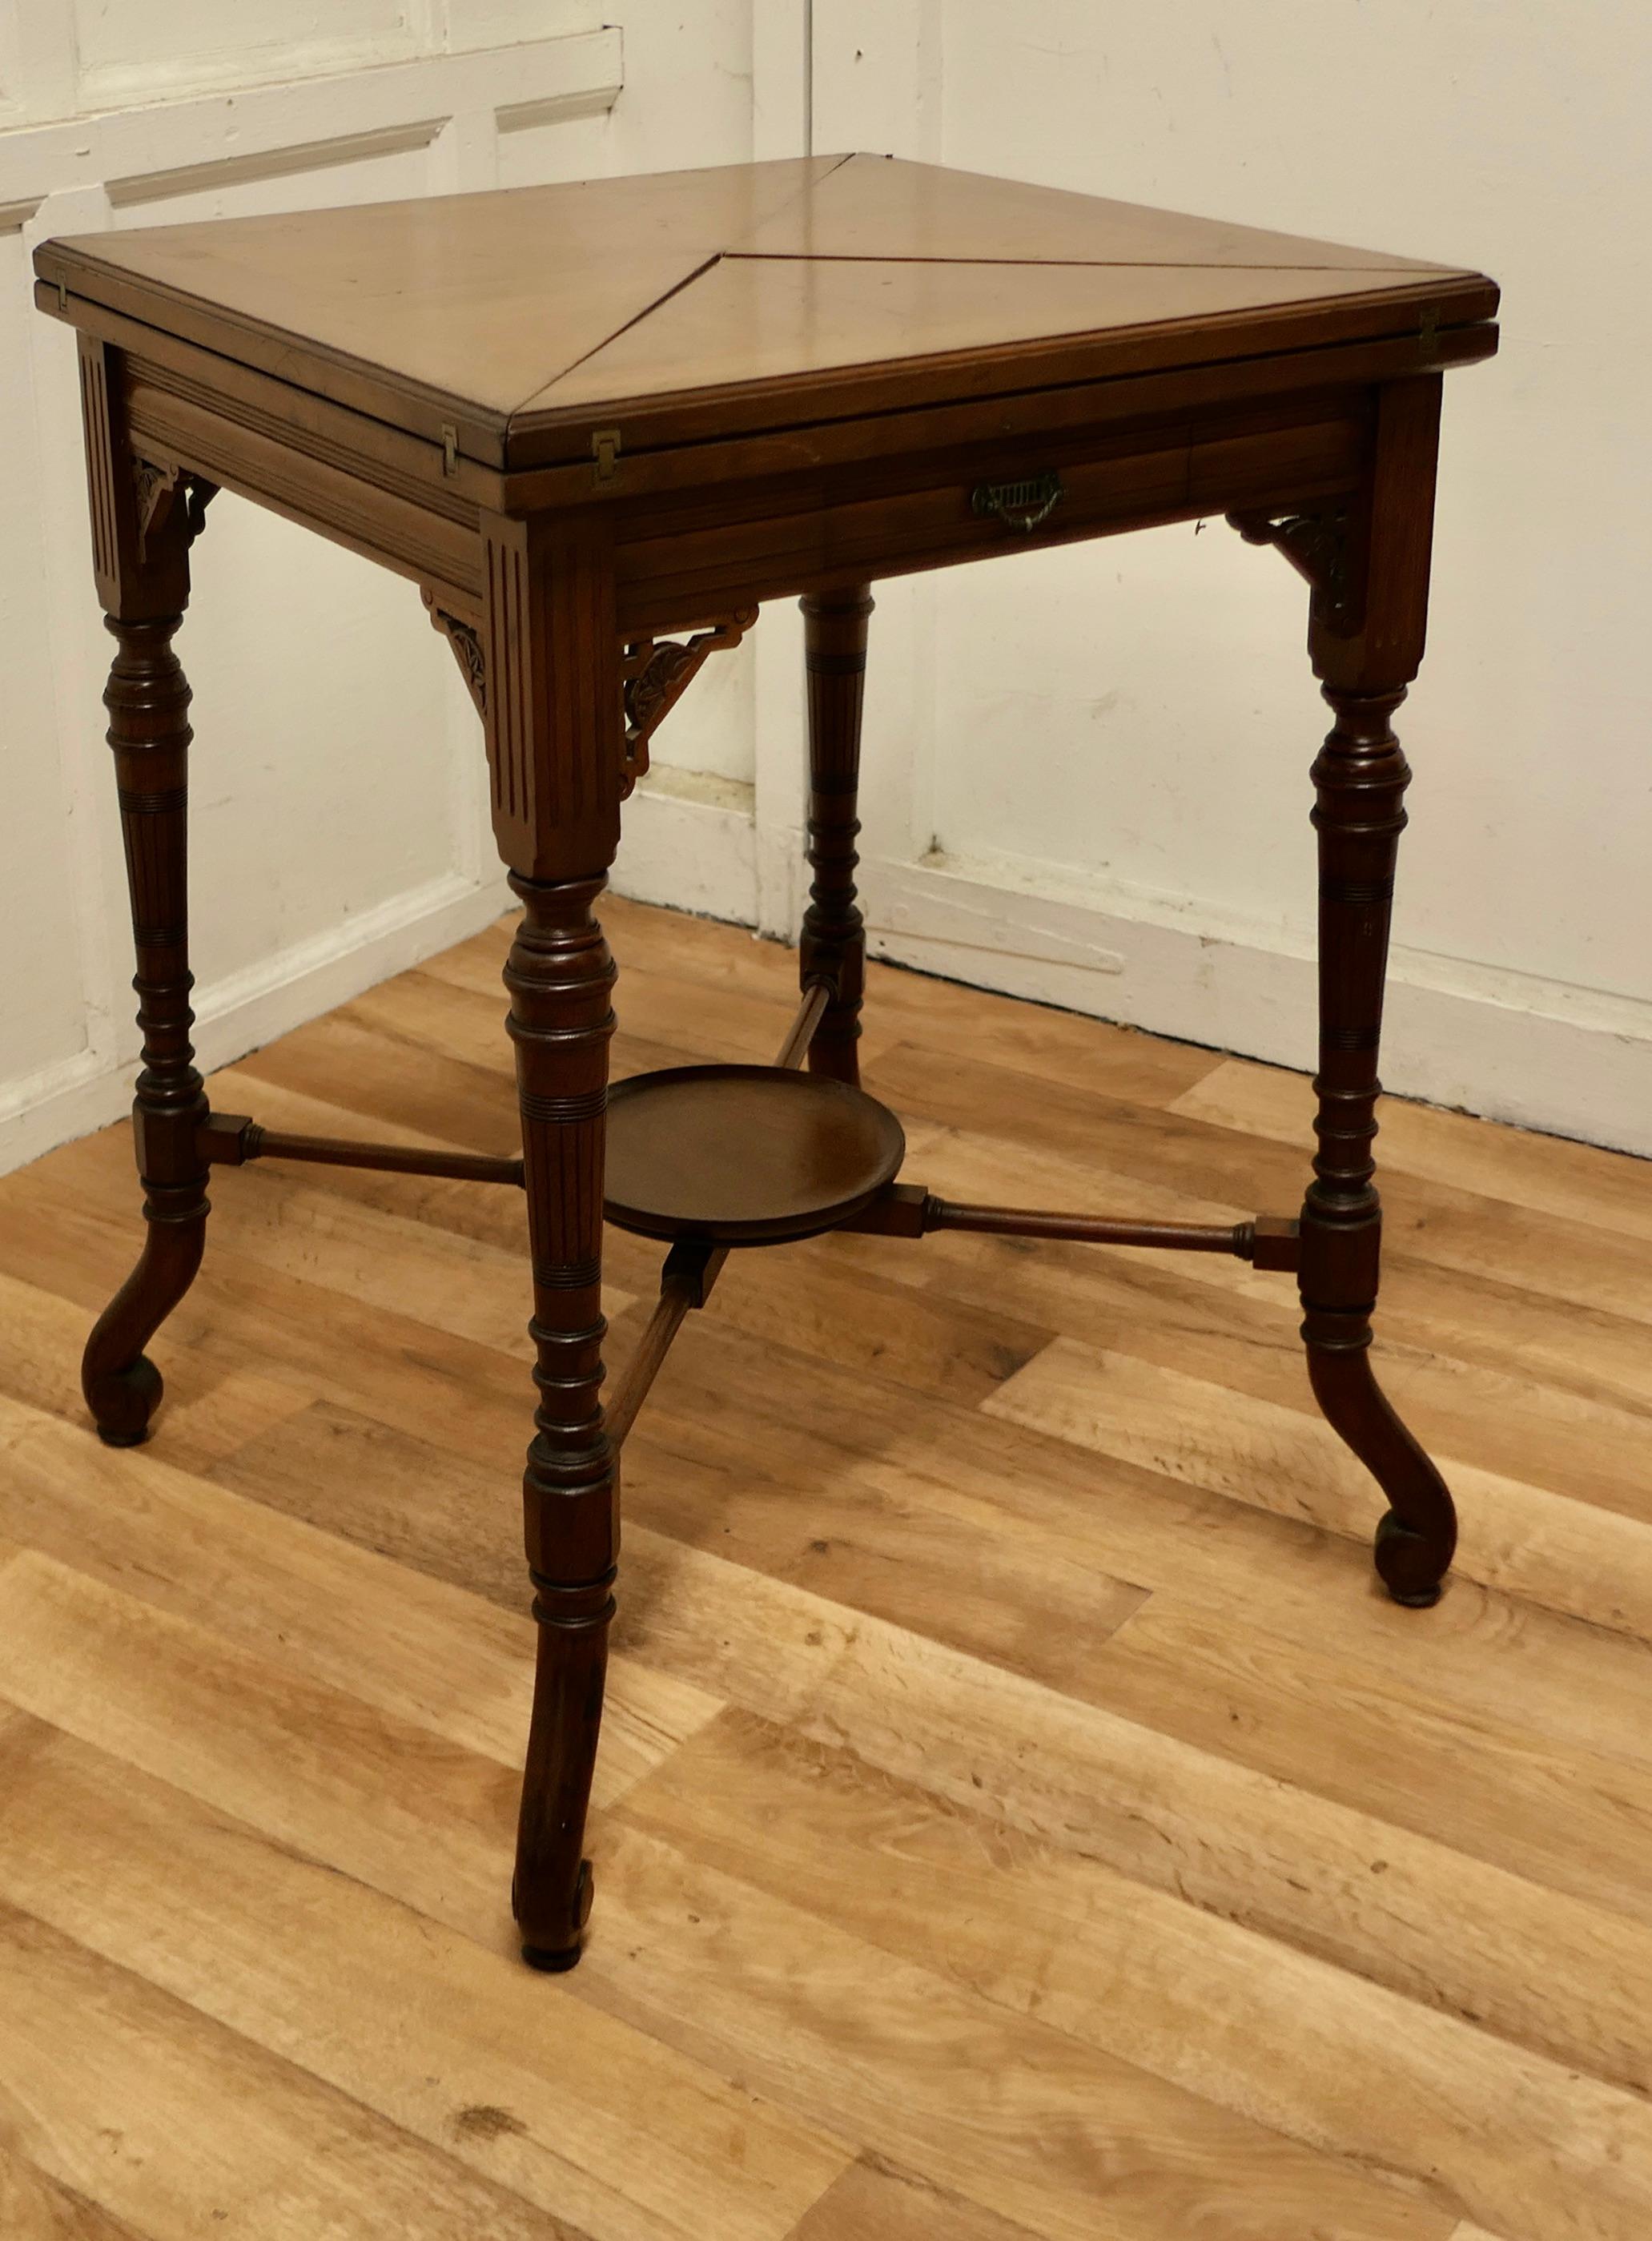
[504,876,619,1969]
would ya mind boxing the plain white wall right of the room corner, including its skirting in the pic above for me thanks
[798,0,1652,1152]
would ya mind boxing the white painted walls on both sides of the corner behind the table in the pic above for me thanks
[0,0,1652,1161]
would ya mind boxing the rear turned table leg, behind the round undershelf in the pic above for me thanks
[798,582,872,1084]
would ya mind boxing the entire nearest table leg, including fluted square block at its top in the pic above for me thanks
[477,509,625,1969]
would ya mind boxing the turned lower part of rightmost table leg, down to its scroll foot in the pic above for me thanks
[1300,686,1457,1607]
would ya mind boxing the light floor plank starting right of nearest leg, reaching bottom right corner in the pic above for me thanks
[623,1712,1652,2241]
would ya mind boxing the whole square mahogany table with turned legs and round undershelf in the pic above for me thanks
[36,157,1497,1969]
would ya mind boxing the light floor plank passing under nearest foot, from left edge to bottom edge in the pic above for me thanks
[0,1555,1444,2241]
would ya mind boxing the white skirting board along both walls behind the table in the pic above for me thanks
[16,771,1652,1172]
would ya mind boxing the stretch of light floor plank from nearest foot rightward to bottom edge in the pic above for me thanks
[578,1822,1455,2241]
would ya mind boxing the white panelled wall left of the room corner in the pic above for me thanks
[0,0,770,1165]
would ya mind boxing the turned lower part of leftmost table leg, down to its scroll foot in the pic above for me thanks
[81,614,207,1448]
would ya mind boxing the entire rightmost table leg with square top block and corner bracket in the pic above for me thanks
[1272,376,1457,1607]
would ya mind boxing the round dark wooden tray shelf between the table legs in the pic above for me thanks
[605,1067,906,1246]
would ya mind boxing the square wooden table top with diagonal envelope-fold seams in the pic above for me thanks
[36,155,1497,469]
